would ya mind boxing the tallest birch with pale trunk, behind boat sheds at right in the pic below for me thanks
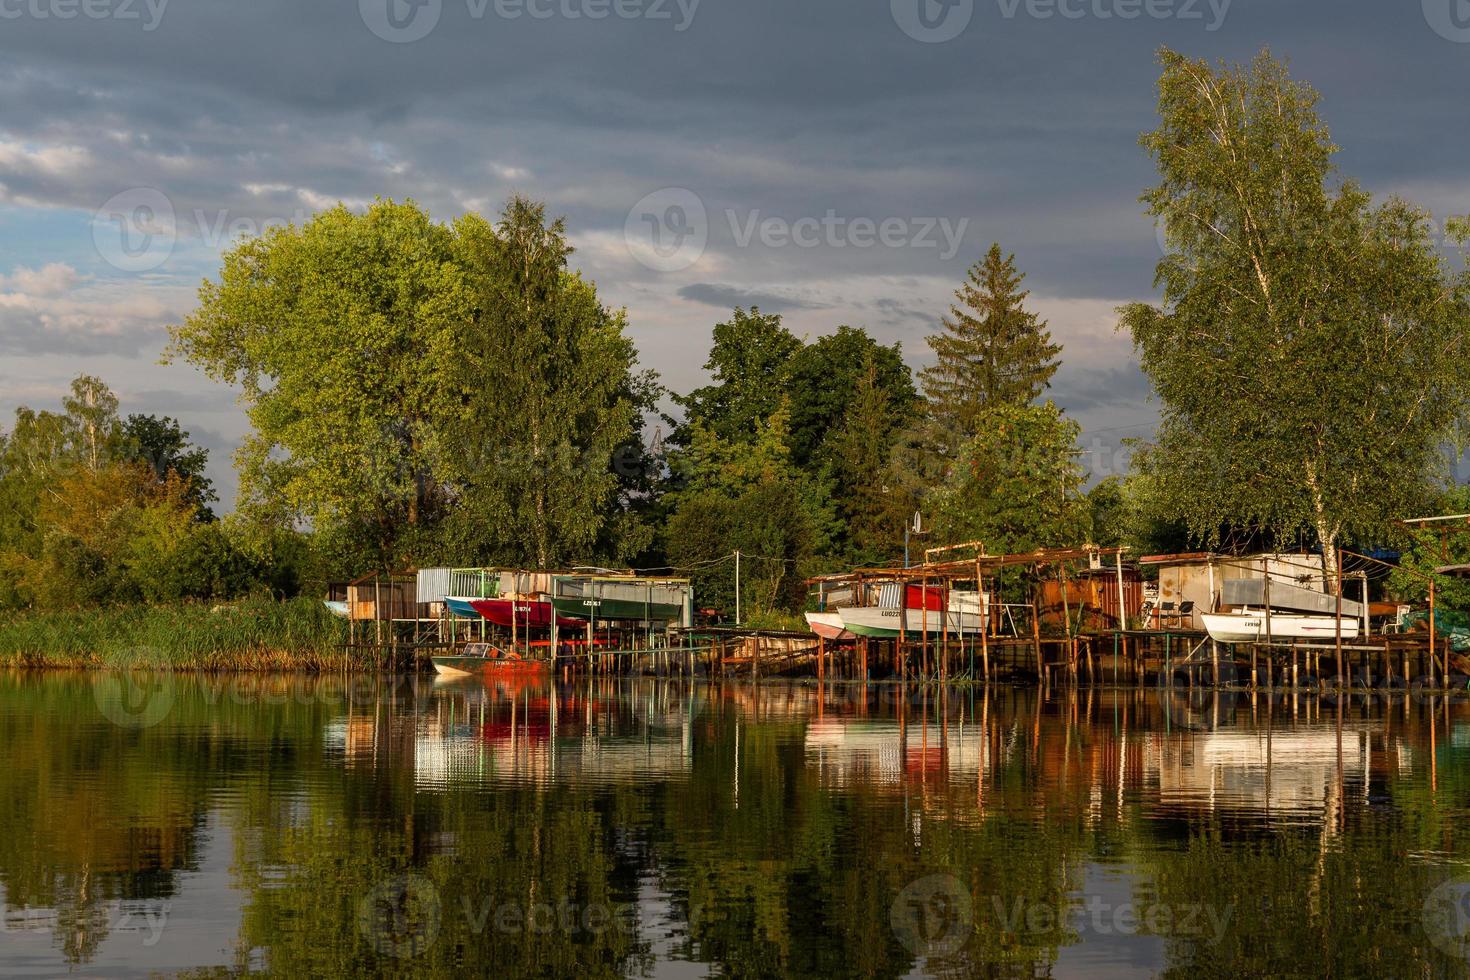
[1120,50,1470,575]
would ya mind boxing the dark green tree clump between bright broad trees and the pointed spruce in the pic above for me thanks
[664,309,919,619]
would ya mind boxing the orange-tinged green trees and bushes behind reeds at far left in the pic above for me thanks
[0,376,270,610]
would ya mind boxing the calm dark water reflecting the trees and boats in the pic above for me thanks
[0,673,1470,977]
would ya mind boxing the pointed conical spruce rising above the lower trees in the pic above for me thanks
[919,244,1061,442]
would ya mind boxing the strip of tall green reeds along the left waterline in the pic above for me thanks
[0,598,355,670]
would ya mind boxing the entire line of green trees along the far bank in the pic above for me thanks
[17,51,1470,621]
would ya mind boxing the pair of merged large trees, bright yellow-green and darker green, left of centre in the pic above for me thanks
[172,198,656,573]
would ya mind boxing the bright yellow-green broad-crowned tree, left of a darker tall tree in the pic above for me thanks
[171,201,475,561]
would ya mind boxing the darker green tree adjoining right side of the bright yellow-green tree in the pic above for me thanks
[453,198,660,569]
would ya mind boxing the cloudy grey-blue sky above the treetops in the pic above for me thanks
[0,0,1470,510]
